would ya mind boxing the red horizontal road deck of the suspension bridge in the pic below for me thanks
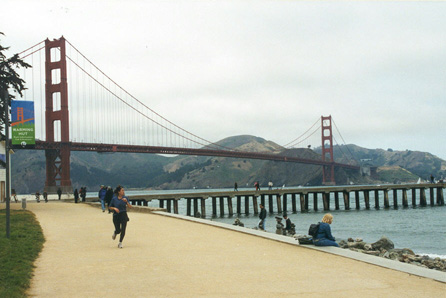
[35,141,359,170]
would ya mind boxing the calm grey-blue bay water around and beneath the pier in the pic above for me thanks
[89,189,446,258]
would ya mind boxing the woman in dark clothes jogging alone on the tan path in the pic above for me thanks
[109,185,132,248]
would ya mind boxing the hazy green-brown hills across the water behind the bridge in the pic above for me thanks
[11,135,446,193]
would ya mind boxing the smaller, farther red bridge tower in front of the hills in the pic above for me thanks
[321,115,336,185]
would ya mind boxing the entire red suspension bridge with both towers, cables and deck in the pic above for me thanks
[12,37,359,192]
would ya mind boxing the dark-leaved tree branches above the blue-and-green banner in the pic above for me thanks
[0,32,31,130]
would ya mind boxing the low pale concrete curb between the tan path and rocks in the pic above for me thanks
[151,211,446,283]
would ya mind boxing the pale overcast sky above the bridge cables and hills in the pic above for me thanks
[0,0,446,159]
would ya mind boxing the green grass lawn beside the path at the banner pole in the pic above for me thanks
[0,209,45,298]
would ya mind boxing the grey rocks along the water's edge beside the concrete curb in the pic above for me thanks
[234,217,446,272]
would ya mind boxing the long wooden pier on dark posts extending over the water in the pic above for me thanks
[129,183,446,217]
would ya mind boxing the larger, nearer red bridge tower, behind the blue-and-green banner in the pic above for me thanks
[45,37,73,193]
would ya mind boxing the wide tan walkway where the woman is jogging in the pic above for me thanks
[4,201,446,297]
